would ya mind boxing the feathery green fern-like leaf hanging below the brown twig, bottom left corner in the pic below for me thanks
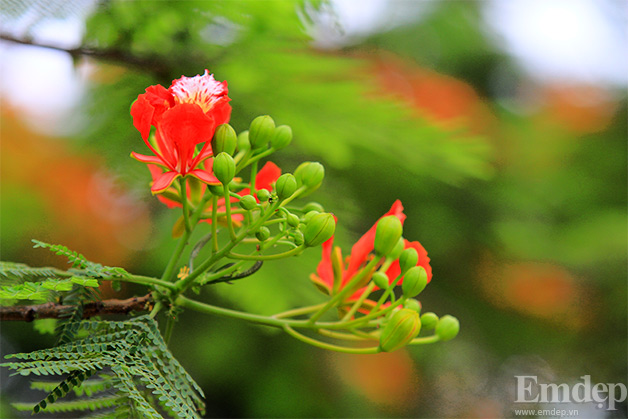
[0,316,204,418]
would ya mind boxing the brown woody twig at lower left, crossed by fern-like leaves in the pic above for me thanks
[0,294,152,322]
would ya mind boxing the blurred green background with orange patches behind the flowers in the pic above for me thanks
[0,0,628,418]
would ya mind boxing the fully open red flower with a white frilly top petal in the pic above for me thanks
[131,70,231,193]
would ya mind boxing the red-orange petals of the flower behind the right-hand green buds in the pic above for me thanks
[310,200,432,300]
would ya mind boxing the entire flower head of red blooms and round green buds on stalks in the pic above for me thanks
[131,71,459,352]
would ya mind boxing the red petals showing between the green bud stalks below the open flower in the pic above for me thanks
[149,159,281,223]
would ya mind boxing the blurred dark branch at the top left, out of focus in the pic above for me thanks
[0,33,169,75]
